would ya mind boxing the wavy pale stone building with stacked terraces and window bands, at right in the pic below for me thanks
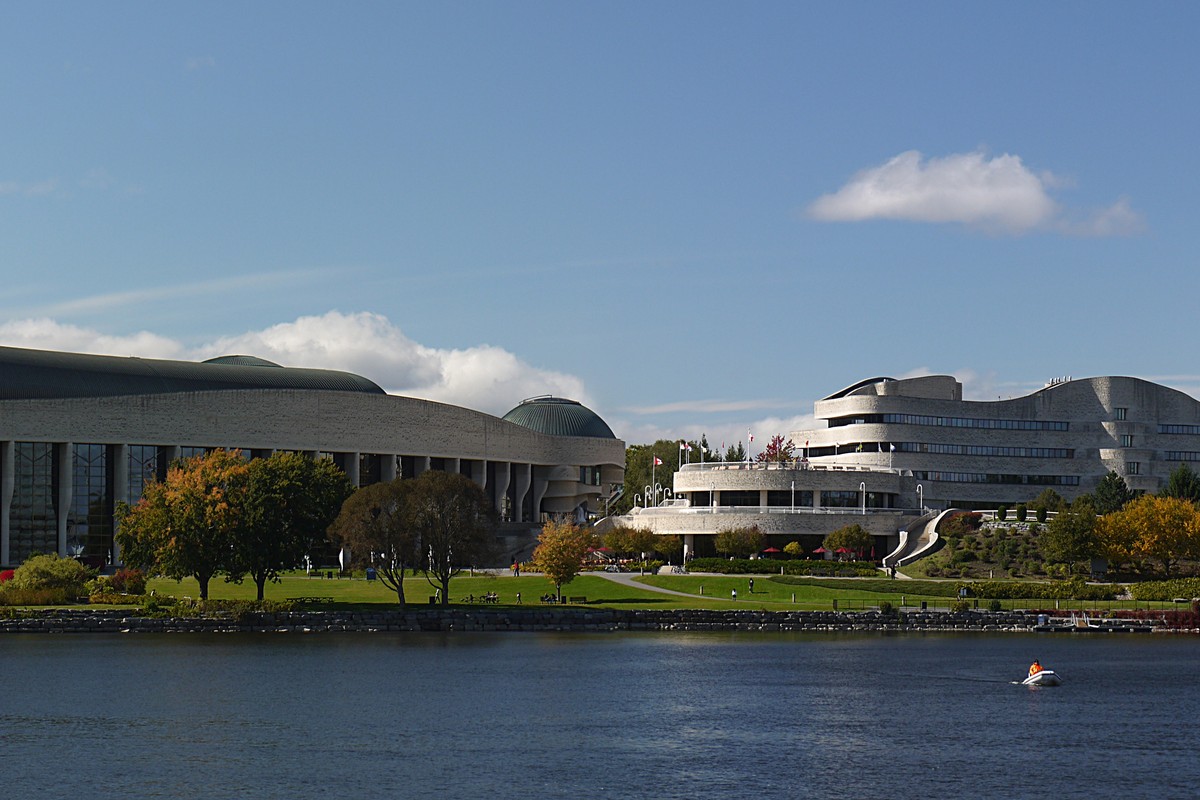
[628,375,1200,563]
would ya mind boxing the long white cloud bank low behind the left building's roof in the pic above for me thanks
[0,311,588,414]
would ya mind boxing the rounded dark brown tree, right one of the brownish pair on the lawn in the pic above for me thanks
[406,470,494,606]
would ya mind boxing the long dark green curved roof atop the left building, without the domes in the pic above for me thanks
[0,347,385,399]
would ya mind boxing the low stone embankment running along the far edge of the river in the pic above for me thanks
[0,607,1180,633]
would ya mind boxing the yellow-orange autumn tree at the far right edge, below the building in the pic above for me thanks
[1099,494,1200,576]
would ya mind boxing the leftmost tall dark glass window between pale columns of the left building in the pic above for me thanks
[8,441,59,564]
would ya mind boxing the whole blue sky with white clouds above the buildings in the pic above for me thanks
[0,2,1200,445]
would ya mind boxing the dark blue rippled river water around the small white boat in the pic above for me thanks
[0,633,1200,800]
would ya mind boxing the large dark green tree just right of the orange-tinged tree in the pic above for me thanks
[226,452,353,602]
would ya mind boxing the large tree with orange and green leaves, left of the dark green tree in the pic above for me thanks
[115,450,248,600]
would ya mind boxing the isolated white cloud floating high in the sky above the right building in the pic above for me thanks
[806,150,1142,236]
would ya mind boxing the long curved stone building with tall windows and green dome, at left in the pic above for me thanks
[0,348,625,566]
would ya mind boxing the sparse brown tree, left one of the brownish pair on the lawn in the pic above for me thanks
[329,479,420,608]
